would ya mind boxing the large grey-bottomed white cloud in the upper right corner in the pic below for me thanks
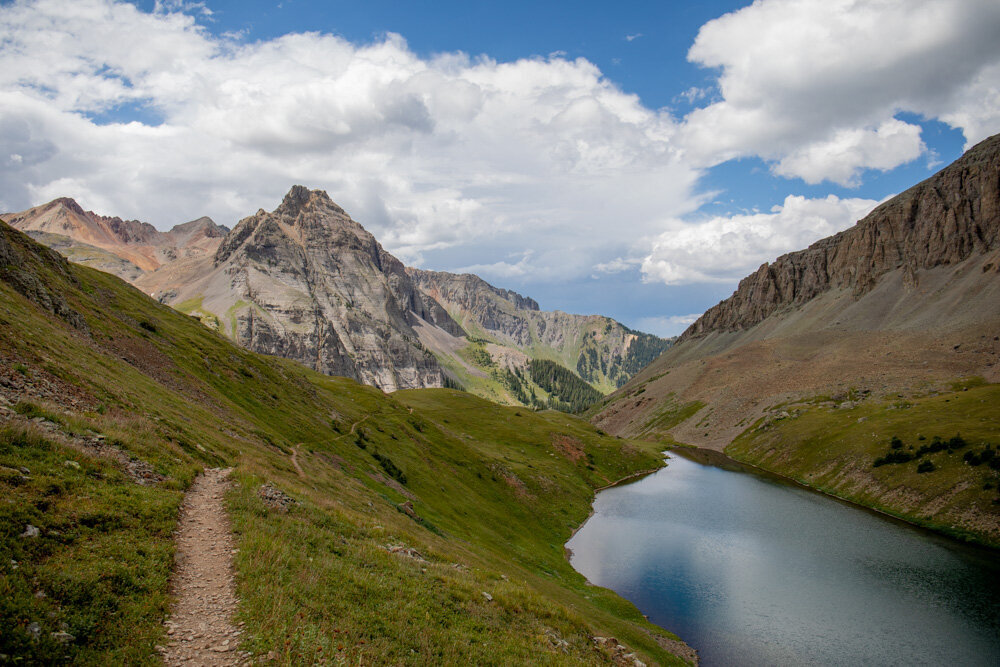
[679,0,1000,185]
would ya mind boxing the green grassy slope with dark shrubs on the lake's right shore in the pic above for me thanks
[726,379,1000,546]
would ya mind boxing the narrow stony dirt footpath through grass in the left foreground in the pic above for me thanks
[163,468,248,665]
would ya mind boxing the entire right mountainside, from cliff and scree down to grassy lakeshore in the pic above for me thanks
[592,135,1000,544]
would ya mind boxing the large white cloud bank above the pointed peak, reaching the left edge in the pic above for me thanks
[0,0,699,286]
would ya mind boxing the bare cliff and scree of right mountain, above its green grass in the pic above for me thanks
[595,130,1000,449]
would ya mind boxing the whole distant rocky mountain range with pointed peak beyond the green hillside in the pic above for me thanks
[2,186,671,409]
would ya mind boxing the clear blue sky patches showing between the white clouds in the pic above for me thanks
[152,0,964,213]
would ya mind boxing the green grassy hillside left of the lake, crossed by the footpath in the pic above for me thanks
[0,225,680,664]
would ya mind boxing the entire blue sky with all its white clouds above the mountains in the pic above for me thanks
[0,0,1000,334]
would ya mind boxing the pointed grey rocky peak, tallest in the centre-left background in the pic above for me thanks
[177,186,464,391]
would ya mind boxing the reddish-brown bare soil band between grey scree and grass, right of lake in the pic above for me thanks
[593,321,1000,451]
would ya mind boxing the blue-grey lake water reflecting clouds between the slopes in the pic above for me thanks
[567,456,1000,667]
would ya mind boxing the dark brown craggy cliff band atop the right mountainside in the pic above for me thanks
[681,135,1000,340]
